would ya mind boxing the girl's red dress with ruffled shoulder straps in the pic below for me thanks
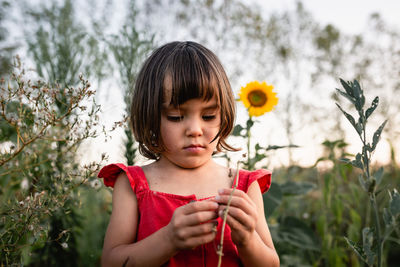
[98,164,271,267]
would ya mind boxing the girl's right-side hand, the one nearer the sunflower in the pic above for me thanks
[215,189,258,247]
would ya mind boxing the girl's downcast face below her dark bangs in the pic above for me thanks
[160,98,221,168]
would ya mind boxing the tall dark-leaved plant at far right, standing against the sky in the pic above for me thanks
[337,79,400,266]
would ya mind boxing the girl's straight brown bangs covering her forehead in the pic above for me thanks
[163,46,221,107]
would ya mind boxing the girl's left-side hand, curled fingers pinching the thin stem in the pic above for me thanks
[166,200,218,250]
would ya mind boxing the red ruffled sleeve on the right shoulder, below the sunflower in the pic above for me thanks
[238,169,272,193]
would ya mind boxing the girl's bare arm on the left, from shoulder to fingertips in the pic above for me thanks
[101,173,218,266]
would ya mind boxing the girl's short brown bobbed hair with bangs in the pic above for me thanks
[130,42,237,159]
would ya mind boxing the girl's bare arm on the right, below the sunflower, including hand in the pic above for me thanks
[217,183,279,266]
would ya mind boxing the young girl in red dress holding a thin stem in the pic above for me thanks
[99,42,279,267]
